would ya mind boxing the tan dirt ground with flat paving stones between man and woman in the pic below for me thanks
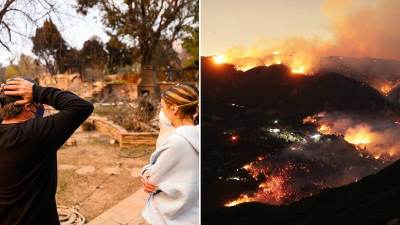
[57,131,154,221]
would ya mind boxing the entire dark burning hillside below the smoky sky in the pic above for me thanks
[201,57,400,224]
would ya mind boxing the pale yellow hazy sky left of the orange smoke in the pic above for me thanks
[201,0,371,55]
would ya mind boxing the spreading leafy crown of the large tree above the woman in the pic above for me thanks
[77,0,198,65]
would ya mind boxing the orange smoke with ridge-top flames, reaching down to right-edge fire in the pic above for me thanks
[209,0,400,92]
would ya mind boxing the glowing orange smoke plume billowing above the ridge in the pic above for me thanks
[219,0,400,72]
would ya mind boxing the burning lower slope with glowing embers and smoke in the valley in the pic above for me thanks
[225,112,400,207]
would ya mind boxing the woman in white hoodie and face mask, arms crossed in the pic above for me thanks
[142,84,199,225]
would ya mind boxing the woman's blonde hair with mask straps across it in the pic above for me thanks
[161,84,199,125]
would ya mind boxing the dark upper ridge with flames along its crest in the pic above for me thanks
[202,55,396,123]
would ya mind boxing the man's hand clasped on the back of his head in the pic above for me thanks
[3,78,33,105]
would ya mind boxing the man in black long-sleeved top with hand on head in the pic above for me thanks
[0,78,93,225]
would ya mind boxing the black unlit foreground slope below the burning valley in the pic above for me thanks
[204,158,400,225]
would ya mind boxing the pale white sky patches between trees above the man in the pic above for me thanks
[0,0,108,65]
